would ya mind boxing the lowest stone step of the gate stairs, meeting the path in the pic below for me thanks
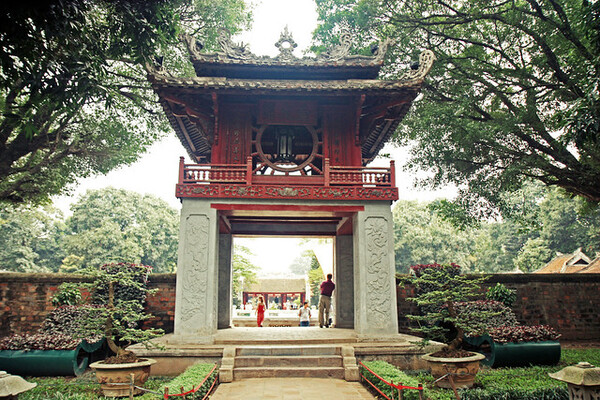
[233,367,344,380]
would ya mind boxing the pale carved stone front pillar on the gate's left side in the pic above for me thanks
[174,199,219,343]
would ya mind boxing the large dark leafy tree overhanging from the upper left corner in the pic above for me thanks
[0,0,247,203]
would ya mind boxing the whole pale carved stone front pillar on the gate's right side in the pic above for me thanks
[353,201,398,340]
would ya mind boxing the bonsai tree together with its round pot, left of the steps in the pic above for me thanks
[83,263,163,397]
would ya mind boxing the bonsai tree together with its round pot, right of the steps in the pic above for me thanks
[407,263,493,388]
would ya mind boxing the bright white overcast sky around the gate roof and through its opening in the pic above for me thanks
[54,0,456,273]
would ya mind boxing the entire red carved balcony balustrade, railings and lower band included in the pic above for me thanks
[177,157,398,200]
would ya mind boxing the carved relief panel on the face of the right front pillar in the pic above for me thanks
[365,217,393,329]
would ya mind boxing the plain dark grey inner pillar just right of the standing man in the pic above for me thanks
[333,235,354,329]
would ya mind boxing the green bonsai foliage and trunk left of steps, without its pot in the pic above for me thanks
[80,263,164,364]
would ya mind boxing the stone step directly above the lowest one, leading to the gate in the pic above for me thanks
[234,355,343,368]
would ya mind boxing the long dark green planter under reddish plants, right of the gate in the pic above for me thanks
[464,335,561,368]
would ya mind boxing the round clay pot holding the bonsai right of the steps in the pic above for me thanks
[421,353,485,389]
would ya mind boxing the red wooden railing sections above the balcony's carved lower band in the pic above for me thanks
[179,157,396,187]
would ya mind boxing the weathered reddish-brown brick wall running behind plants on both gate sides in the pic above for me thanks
[0,273,600,341]
